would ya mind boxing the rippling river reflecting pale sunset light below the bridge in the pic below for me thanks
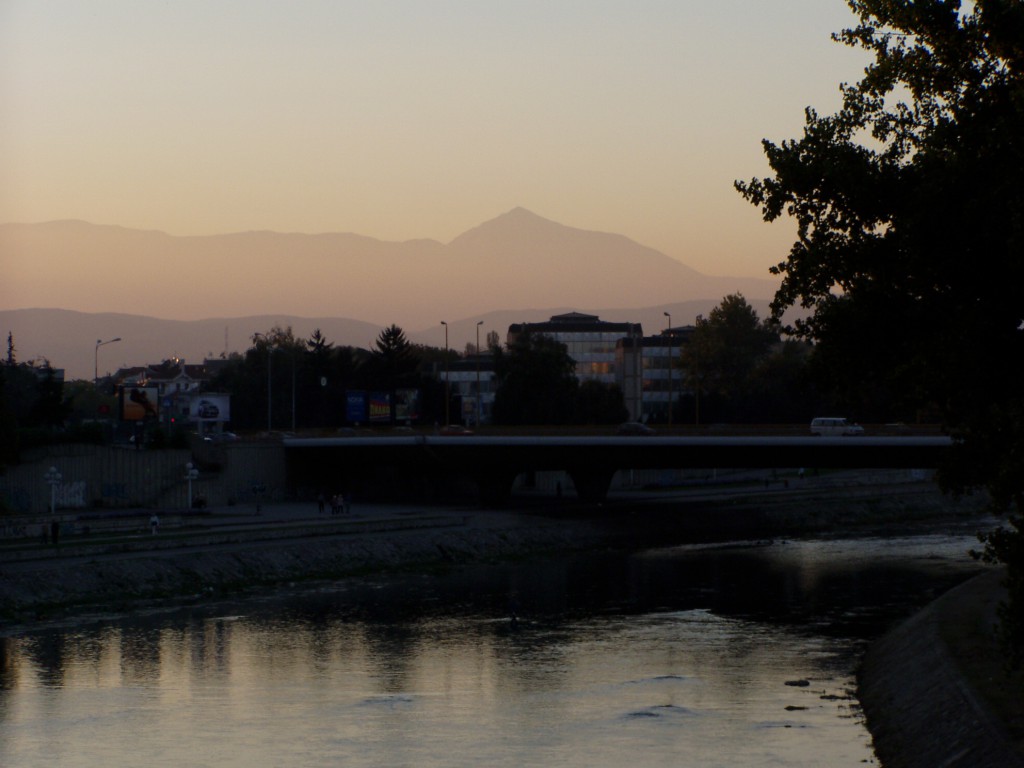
[0,521,995,768]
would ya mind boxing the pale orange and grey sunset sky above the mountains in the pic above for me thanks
[0,0,866,276]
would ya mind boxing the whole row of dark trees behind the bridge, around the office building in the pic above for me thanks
[212,294,847,429]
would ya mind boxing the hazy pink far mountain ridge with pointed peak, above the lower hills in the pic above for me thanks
[0,208,774,331]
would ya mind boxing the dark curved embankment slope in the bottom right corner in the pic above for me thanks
[858,570,1024,768]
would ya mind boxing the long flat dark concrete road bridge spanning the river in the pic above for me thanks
[284,435,952,505]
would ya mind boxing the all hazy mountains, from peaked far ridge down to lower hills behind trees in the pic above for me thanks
[0,208,777,378]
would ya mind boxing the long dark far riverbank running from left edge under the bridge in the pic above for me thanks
[0,472,983,632]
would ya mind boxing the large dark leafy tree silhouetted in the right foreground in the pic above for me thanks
[736,0,1024,659]
